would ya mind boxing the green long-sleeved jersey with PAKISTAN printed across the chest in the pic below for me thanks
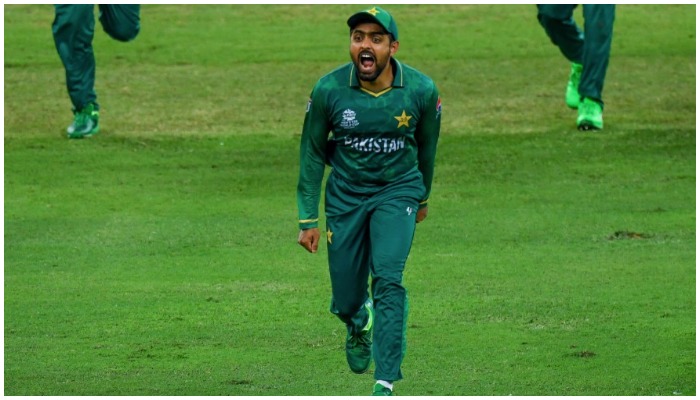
[297,58,442,229]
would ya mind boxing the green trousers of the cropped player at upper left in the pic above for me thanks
[52,4,141,110]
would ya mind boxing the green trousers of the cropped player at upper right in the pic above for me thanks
[537,4,615,105]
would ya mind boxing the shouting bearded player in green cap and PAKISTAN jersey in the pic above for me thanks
[297,7,442,395]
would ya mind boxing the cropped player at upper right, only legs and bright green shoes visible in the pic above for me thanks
[537,4,615,130]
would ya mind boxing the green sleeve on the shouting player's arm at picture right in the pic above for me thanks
[415,84,442,208]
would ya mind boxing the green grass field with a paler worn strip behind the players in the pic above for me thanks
[4,5,696,396]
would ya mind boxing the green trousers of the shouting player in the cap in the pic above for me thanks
[325,171,425,382]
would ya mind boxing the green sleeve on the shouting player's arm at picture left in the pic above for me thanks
[297,84,330,229]
